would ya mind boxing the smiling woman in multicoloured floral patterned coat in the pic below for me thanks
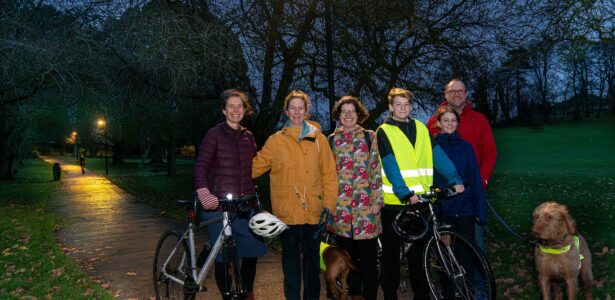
[329,96,383,300]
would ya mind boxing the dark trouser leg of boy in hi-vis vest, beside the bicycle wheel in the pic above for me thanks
[380,205,404,300]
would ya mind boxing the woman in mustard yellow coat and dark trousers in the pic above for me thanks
[252,91,338,300]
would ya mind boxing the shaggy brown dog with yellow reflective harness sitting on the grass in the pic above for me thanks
[532,202,593,299]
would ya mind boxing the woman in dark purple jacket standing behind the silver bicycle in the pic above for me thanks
[194,90,267,299]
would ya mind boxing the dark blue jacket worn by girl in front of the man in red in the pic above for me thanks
[434,133,487,225]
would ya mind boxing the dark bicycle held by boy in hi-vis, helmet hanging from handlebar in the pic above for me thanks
[394,188,496,299]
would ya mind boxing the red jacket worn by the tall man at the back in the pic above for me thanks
[427,100,497,187]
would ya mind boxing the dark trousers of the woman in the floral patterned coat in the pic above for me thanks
[337,236,378,300]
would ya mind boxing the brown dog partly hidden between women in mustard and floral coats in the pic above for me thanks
[322,246,358,300]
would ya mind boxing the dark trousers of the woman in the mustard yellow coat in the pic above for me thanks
[281,224,320,300]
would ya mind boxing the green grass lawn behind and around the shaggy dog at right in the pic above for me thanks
[487,119,615,299]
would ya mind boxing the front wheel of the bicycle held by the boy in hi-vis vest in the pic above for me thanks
[423,230,496,300]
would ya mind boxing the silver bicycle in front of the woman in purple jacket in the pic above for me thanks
[153,194,258,299]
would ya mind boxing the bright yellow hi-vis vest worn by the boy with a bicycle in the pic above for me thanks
[379,120,433,205]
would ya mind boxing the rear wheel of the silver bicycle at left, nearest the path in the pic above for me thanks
[154,230,195,300]
